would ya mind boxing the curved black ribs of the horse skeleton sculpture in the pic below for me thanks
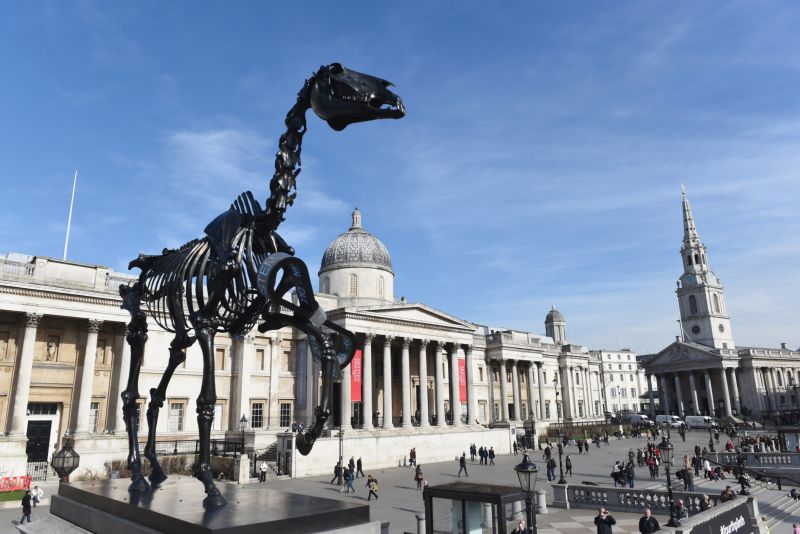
[139,227,267,335]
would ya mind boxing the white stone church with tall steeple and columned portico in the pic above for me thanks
[643,191,800,417]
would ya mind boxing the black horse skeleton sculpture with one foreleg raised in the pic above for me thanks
[119,63,405,506]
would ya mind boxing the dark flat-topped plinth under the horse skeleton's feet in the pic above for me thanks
[50,477,380,534]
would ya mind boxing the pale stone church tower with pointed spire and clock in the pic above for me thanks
[676,188,735,349]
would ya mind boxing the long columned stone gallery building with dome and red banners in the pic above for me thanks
[0,209,605,474]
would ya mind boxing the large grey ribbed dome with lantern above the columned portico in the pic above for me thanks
[319,208,394,274]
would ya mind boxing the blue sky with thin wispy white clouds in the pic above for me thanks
[0,1,800,352]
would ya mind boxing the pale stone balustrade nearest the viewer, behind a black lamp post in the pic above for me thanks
[553,484,719,515]
